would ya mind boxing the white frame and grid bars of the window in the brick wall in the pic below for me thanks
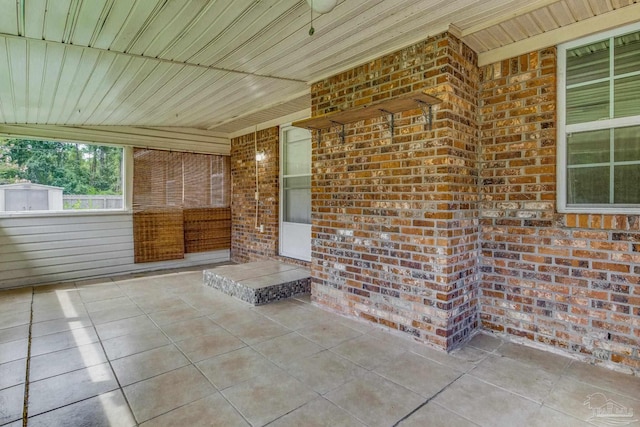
[556,22,640,214]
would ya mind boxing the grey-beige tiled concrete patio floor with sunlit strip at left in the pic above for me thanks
[0,272,640,427]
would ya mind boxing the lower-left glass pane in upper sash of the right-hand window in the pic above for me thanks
[567,82,609,124]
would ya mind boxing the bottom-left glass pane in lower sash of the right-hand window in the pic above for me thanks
[567,166,609,205]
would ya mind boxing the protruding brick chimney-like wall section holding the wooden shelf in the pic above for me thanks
[311,33,479,349]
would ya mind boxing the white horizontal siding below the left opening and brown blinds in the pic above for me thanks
[0,213,229,289]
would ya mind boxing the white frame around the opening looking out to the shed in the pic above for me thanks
[0,137,133,218]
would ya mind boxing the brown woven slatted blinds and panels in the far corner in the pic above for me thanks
[133,149,231,262]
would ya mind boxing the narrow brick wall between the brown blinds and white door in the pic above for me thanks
[231,127,279,262]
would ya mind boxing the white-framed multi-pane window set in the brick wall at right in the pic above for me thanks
[558,24,640,213]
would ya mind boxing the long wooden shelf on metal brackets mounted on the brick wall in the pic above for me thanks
[292,92,441,130]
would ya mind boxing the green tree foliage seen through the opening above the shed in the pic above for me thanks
[0,139,122,194]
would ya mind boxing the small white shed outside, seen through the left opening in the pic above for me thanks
[0,182,63,212]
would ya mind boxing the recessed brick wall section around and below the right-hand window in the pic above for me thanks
[479,49,640,373]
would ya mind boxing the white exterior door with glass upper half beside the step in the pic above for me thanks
[280,126,311,261]
